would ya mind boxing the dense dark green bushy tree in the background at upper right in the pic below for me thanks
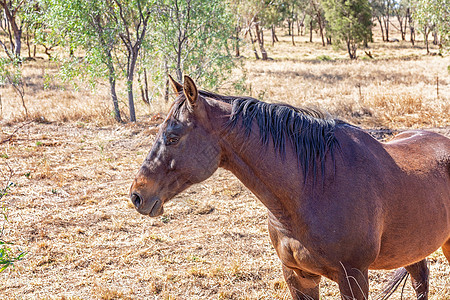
[322,0,372,59]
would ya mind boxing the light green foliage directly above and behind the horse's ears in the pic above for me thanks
[143,0,234,93]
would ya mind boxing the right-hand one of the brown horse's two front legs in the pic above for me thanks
[338,264,369,300]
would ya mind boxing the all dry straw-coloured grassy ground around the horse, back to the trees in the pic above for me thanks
[0,24,450,300]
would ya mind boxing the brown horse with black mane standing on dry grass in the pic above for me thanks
[131,77,450,300]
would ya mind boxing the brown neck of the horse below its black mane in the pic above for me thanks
[211,105,303,221]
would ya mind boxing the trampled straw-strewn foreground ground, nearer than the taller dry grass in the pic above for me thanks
[0,123,450,300]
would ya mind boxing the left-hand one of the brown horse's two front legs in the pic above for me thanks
[283,265,321,300]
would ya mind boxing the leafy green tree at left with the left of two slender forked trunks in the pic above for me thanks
[40,0,122,122]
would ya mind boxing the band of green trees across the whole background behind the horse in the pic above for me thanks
[0,0,450,122]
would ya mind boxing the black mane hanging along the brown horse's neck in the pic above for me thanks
[228,98,344,180]
